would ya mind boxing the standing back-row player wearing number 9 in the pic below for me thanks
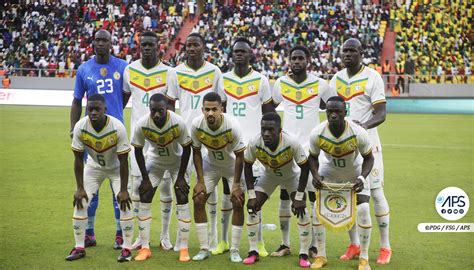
[271,45,336,257]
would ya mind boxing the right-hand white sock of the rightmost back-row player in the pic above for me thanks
[371,188,390,249]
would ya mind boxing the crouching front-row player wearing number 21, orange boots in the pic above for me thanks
[132,94,192,262]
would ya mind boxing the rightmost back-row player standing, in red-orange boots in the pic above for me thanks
[330,38,392,264]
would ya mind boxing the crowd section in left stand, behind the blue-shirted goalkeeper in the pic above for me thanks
[0,0,188,77]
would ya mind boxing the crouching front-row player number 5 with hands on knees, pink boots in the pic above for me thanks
[244,112,311,267]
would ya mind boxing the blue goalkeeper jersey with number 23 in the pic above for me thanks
[74,55,127,123]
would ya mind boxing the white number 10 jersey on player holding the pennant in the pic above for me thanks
[309,121,372,183]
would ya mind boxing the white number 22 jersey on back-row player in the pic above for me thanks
[223,70,272,144]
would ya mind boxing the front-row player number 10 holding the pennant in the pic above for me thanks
[309,96,374,270]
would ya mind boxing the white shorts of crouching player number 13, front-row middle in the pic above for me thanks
[202,160,245,194]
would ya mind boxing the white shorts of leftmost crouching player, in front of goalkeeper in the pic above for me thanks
[84,164,120,205]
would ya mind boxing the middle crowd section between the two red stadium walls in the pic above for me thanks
[171,0,389,79]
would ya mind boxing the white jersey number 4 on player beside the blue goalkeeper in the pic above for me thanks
[123,59,176,139]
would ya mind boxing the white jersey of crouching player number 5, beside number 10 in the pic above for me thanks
[244,131,307,180]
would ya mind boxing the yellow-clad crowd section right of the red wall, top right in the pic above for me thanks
[390,0,472,83]
